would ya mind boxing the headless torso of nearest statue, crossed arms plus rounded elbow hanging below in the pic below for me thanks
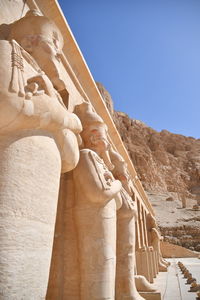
[0,41,82,172]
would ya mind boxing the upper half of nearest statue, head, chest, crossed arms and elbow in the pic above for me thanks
[0,10,81,172]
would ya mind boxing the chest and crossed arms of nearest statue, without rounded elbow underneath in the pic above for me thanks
[0,40,81,133]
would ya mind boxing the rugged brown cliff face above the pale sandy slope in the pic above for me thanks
[114,112,200,199]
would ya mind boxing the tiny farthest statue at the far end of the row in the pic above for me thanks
[147,213,169,272]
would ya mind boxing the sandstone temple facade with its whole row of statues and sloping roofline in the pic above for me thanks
[0,0,168,300]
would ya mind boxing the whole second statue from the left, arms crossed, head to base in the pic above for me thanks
[73,102,121,300]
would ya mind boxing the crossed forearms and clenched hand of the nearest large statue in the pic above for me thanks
[0,74,82,133]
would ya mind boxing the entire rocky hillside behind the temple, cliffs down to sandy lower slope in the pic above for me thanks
[97,83,200,250]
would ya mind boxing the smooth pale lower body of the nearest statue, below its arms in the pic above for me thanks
[0,130,61,300]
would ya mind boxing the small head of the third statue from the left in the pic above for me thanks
[109,149,133,196]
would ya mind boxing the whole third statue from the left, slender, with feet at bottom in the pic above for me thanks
[110,150,143,300]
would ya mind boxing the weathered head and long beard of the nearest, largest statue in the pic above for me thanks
[8,10,64,90]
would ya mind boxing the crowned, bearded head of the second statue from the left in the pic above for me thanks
[74,102,113,170]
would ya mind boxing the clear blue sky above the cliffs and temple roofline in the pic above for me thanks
[58,0,200,138]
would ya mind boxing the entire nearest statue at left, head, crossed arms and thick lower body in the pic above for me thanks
[0,10,81,300]
